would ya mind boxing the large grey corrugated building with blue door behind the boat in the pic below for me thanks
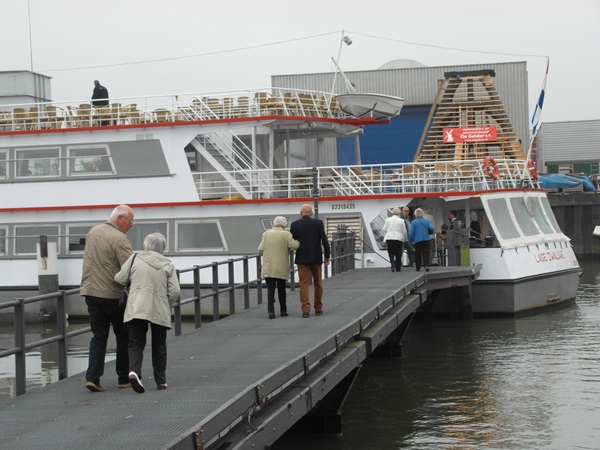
[271,62,529,166]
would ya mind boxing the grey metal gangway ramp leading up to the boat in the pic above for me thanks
[0,267,479,450]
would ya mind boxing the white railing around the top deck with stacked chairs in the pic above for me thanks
[0,88,349,132]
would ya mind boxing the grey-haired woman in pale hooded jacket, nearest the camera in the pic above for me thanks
[115,233,180,394]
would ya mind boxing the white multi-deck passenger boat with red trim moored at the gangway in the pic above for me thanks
[0,79,580,314]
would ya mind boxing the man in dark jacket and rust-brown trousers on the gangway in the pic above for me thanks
[290,204,331,319]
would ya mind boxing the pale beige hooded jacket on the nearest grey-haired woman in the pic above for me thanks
[115,252,181,328]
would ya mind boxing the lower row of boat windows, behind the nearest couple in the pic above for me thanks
[0,220,227,257]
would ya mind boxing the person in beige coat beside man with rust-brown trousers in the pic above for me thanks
[258,216,300,319]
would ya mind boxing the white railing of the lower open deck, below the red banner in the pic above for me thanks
[193,159,539,200]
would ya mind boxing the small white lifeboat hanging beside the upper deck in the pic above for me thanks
[335,93,404,119]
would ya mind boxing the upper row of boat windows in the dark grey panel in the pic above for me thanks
[0,144,116,179]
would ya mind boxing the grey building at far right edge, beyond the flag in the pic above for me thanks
[536,120,600,178]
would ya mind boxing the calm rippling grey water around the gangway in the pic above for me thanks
[0,262,600,450]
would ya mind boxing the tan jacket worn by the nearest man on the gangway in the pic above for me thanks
[81,222,133,300]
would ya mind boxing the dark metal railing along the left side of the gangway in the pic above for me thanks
[0,235,354,396]
